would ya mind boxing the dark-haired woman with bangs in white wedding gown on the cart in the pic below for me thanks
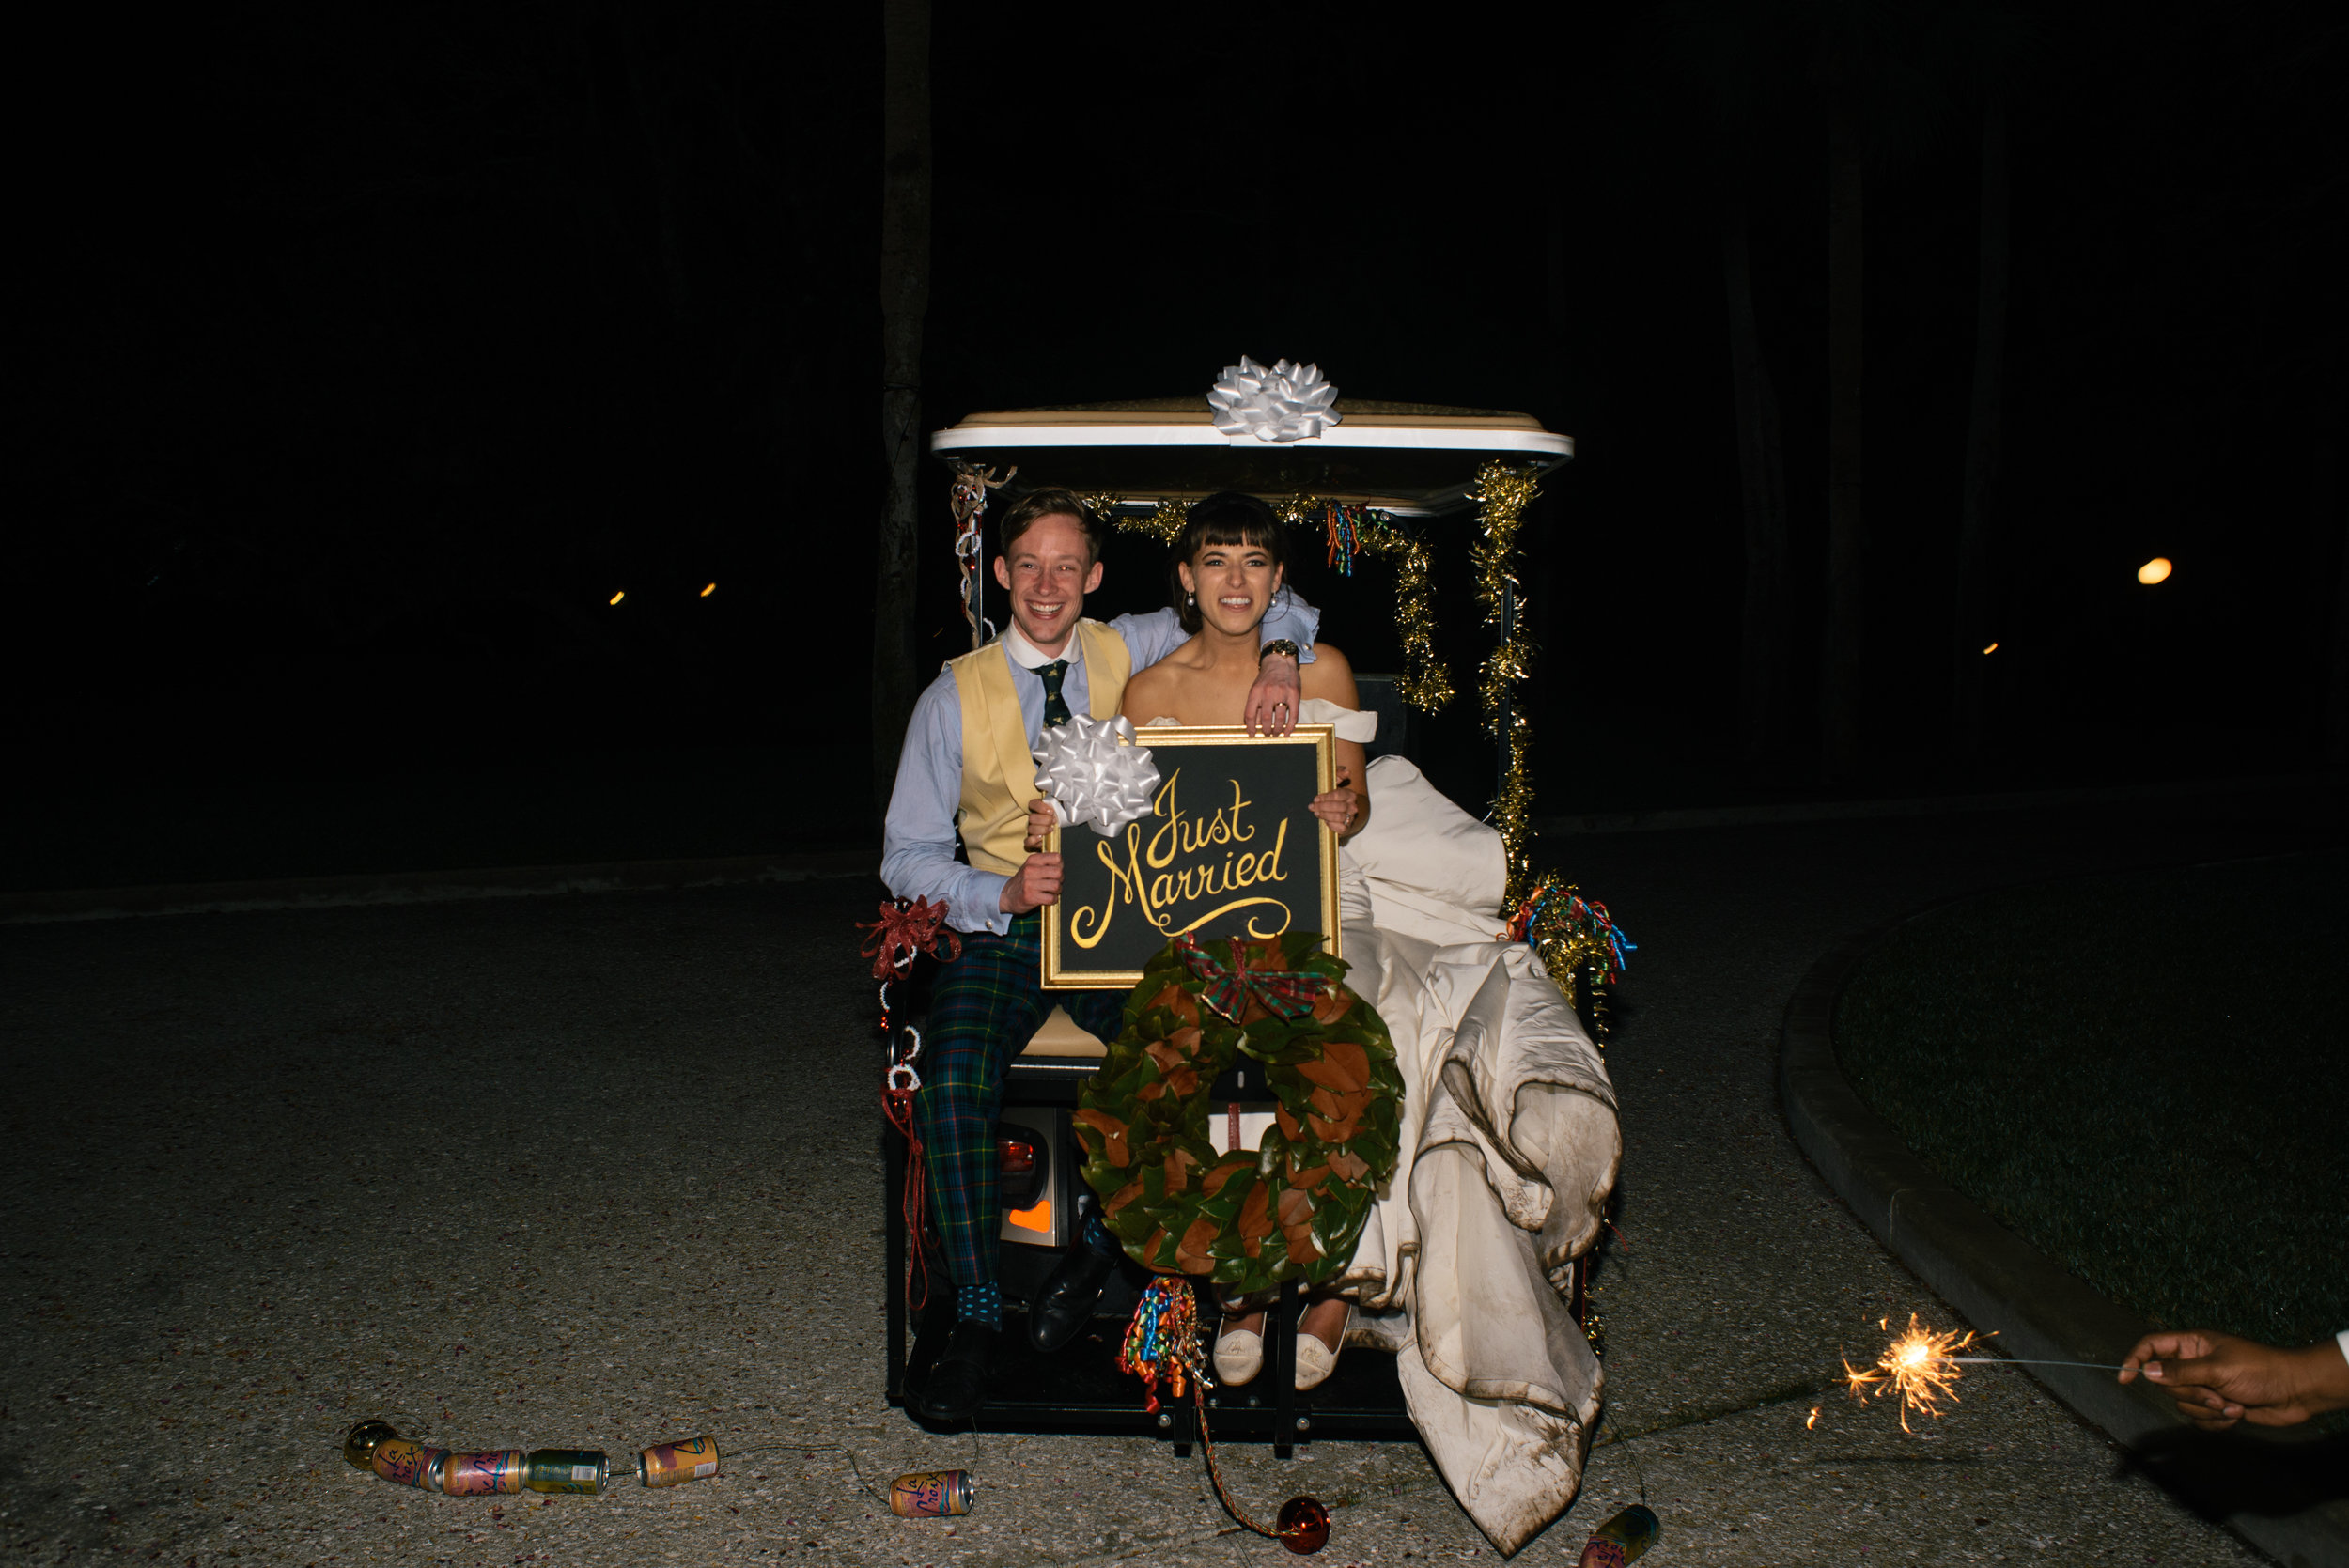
[1123,490,1621,1552]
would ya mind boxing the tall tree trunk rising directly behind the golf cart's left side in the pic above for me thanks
[872,0,930,810]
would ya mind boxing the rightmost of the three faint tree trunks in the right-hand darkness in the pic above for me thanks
[1950,96,2009,770]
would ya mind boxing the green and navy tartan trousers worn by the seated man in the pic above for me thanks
[914,910,1126,1286]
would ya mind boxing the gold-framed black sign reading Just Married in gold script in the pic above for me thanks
[1043,725,1342,990]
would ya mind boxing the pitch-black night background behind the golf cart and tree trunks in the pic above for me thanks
[5,0,2349,849]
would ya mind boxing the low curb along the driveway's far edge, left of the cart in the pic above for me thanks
[0,847,881,924]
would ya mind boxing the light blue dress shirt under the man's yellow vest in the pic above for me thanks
[881,587,1320,937]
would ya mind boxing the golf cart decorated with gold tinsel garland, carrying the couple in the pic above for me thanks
[881,373,1574,1455]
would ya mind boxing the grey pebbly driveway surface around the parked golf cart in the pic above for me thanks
[0,798,2340,1568]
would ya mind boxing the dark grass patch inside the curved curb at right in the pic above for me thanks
[1835,854,2349,1345]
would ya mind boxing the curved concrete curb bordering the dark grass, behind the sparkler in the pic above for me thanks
[1779,906,2349,1568]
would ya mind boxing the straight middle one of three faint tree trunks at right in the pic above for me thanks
[1818,92,1868,780]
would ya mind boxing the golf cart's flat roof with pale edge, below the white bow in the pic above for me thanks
[930,396,1574,514]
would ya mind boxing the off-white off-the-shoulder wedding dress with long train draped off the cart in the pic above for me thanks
[1151,697,1624,1552]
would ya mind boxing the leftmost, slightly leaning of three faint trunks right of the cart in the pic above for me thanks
[1722,199,1793,770]
